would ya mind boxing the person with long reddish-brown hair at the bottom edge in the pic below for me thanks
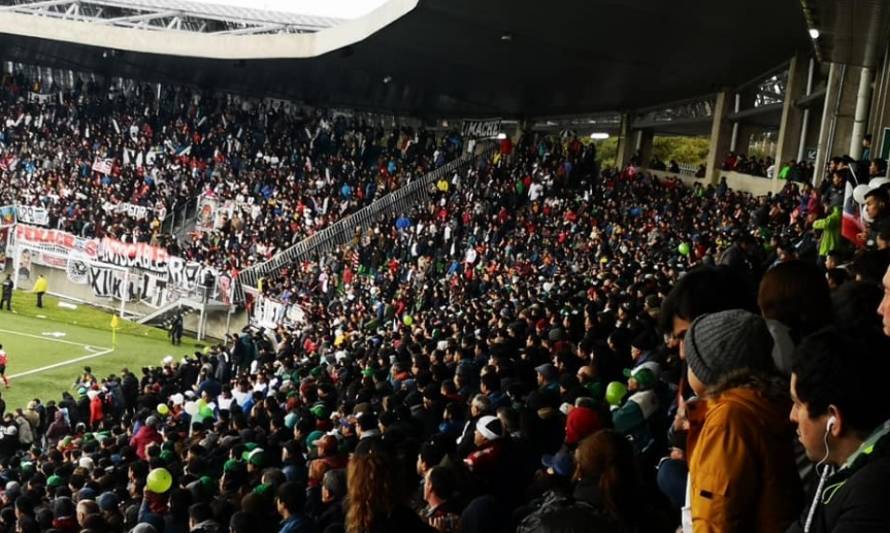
[346,438,434,533]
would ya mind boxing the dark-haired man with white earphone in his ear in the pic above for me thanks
[788,329,890,533]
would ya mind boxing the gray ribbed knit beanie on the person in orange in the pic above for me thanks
[684,309,774,385]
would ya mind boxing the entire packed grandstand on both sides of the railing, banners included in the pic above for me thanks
[0,1,890,533]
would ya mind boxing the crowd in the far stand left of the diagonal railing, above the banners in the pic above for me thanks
[0,73,462,272]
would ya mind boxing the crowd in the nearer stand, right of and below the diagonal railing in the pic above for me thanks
[0,75,890,533]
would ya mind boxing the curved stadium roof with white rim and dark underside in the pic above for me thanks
[0,0,810,117]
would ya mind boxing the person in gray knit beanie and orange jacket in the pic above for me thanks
[684,309,800,533]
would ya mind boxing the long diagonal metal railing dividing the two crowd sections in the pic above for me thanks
[235,147,494,290]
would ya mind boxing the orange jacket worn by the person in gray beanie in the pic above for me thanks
[687,380,801,533]
